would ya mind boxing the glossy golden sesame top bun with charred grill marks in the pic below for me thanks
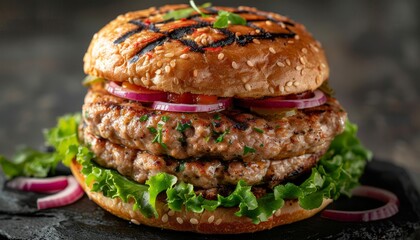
[84,5,329,98]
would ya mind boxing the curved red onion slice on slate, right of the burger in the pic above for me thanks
[321,186,399,222]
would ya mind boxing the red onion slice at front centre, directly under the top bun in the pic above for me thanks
[152,98,232,112]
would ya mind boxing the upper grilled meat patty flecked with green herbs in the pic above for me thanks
[83,85,346,162]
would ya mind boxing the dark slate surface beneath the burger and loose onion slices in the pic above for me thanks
[0,161,420,240]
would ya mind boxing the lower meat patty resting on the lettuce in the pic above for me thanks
[80,129,321,189]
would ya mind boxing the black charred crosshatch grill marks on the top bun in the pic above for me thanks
[113,5,296,63]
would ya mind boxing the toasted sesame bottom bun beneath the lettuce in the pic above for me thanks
[70,160,332,234]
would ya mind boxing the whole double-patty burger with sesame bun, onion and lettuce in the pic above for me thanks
[64,2,368,234]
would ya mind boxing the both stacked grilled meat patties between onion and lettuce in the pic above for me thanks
[80,85,346,189]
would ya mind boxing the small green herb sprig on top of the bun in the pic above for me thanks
[163,0,246,28]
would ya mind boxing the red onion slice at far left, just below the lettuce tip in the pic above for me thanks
[6,176,68,193]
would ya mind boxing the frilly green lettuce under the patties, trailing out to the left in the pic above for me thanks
[0,115,372,224]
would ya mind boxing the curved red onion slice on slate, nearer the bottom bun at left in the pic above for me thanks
[37,176,84,209]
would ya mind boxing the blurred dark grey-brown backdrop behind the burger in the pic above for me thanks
[0,0,420,237]
